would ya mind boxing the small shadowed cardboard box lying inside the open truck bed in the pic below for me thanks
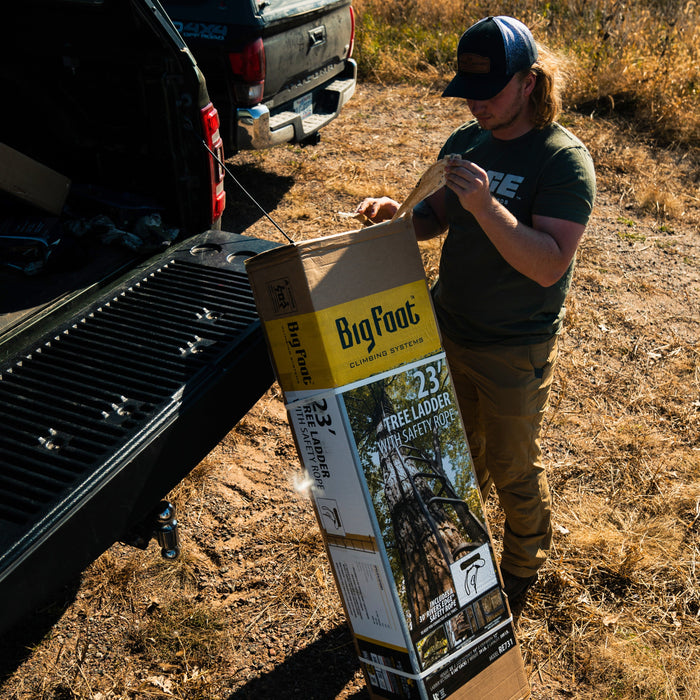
[0,143,71,216]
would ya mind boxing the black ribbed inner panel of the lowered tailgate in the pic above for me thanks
[0,254,257,540]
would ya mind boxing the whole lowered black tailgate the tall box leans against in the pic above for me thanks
[0,231,273,627]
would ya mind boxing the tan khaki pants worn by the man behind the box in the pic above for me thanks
[443,334,557,576]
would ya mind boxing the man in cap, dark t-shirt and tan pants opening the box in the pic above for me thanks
[358,17,595,602]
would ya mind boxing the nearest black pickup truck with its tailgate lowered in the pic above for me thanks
[0,0,275,635]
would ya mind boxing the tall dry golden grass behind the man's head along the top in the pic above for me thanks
[354,0,700,147]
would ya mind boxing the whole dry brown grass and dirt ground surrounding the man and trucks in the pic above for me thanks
[0,0,700,700]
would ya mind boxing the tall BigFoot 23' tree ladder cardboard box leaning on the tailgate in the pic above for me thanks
[247,178,529,700]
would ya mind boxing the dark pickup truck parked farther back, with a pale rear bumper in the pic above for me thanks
[163,0,357,155]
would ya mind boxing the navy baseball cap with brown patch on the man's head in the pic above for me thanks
[442,16,537,100]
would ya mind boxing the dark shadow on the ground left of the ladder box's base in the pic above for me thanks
[226,625,369,700]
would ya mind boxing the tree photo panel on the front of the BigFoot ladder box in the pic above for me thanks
[344,359,505,663]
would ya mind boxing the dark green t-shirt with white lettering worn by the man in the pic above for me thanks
[433,121,595,345]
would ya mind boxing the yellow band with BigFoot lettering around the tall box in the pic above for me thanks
[265,280,440,391]
